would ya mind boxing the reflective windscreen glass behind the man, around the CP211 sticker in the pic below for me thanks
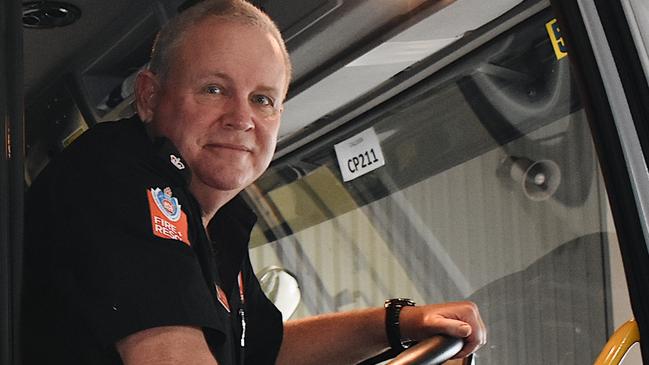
[247,9,616,364]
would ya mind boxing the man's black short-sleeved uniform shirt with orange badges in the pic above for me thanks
[21,118,282,365]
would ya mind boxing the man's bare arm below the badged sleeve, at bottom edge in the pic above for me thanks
[116,326,218,365]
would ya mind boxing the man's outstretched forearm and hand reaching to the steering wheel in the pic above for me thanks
[277,302,487,365]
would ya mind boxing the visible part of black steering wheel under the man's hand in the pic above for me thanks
[357,335,474,365]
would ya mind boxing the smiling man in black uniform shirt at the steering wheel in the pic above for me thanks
[23,0,486,365]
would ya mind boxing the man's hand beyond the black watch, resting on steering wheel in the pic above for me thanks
[400,302,487,359]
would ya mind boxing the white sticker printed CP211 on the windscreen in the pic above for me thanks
[334,128,385,181]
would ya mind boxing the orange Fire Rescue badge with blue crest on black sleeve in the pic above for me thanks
[147,187,190,245]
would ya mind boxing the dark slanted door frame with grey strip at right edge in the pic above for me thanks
[550,0,649,362]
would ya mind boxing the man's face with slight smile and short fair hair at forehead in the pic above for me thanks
[151,19,287,191]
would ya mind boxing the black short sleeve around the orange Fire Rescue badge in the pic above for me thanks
[50,154,226,346]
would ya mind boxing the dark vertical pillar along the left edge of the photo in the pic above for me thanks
[0,0,24,365]
